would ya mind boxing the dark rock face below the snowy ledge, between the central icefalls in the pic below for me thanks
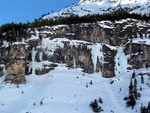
[53,43,93,73]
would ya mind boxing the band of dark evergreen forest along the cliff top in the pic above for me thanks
[0,11,150,42]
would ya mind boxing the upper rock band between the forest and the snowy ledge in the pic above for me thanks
[39,19,150,46]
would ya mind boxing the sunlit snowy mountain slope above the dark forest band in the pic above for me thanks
[43,0,150,19]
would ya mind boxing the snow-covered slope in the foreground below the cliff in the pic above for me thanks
[0,67,150,113]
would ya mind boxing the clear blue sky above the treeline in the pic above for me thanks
[0,0,79,25]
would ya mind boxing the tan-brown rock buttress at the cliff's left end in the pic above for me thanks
[5,44,26,84]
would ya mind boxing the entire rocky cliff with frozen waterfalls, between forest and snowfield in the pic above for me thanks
[0,19,150,83]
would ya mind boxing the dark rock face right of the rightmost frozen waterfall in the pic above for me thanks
[125,43,150,69]
